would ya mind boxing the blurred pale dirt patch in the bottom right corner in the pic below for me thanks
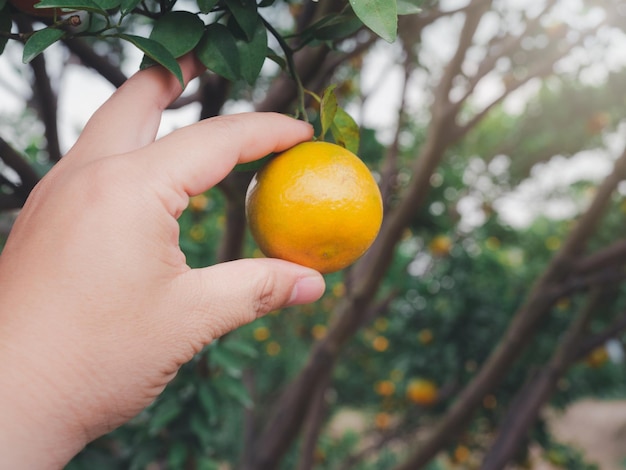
[537,400,626,470]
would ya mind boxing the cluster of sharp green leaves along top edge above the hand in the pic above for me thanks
[0,0,419,90]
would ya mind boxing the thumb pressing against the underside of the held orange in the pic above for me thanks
[172,259,325,345]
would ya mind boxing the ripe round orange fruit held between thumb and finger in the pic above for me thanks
[246,142,383,273]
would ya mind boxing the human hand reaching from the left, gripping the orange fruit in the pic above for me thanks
[0,56,324,469]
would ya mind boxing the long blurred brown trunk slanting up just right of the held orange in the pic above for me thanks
[241,2,490,469]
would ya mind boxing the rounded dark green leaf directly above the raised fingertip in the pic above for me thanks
[150,11,204,58]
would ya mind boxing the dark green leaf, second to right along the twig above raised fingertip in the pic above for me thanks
[196,23,241,82]
